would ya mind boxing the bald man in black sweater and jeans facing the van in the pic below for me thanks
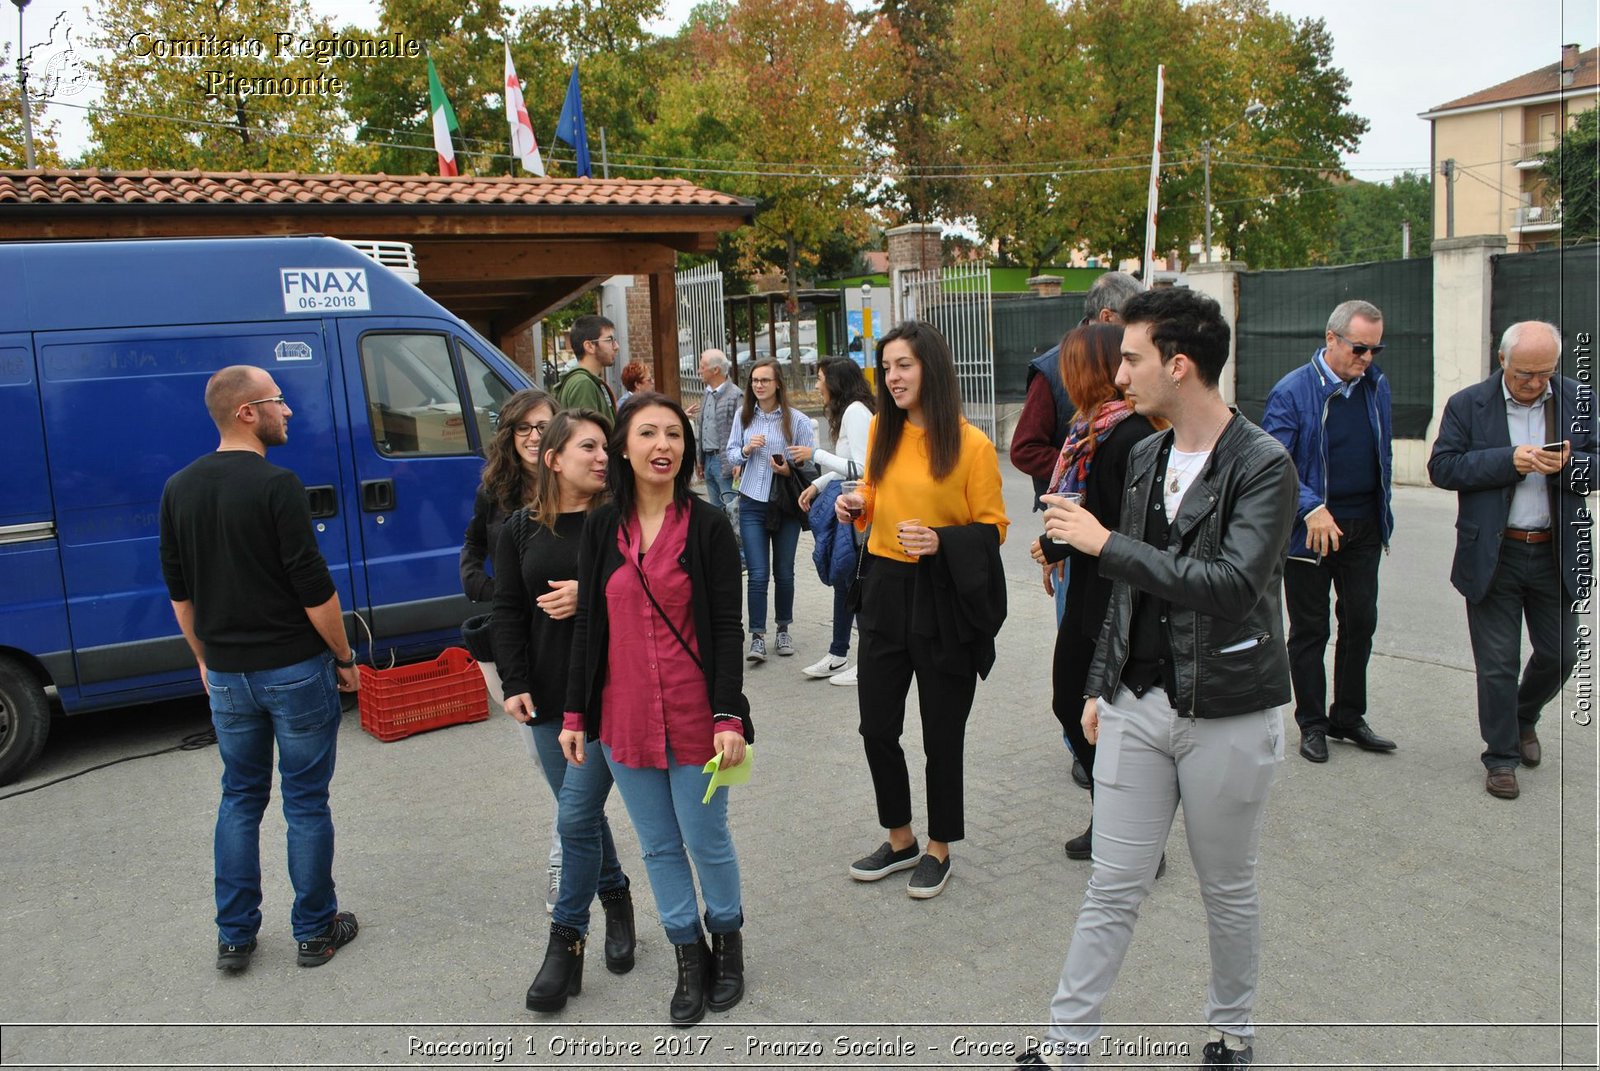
[162,365,360,972]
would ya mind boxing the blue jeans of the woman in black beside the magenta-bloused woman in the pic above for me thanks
[533,719,627,933]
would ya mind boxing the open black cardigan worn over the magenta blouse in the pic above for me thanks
[566,496,755,740]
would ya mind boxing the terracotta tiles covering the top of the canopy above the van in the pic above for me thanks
[0,168,752,210]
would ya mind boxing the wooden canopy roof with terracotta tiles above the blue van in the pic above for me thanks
[0,170,755,354]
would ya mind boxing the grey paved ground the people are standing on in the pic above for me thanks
[0,454,1597,1068]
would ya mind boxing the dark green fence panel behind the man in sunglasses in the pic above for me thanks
[1237,256,1434,439]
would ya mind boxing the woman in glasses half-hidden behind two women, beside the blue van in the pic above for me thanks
[461,387,578,911]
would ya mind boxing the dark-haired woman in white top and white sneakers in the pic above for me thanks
[789,357,874,687]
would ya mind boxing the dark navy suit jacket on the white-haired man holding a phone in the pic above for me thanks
[1427,371,1595,604]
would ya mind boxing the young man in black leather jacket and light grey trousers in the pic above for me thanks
[1021,290,1298,1068]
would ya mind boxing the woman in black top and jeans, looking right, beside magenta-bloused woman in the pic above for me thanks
[493,410,634,1012]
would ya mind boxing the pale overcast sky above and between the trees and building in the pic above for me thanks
[15,0,1600,179]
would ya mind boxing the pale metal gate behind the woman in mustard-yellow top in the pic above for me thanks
[894,261,998,442]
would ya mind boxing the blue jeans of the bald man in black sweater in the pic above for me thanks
[206,653,339,945]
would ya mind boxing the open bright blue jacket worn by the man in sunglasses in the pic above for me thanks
[1261,349,1395,560]
